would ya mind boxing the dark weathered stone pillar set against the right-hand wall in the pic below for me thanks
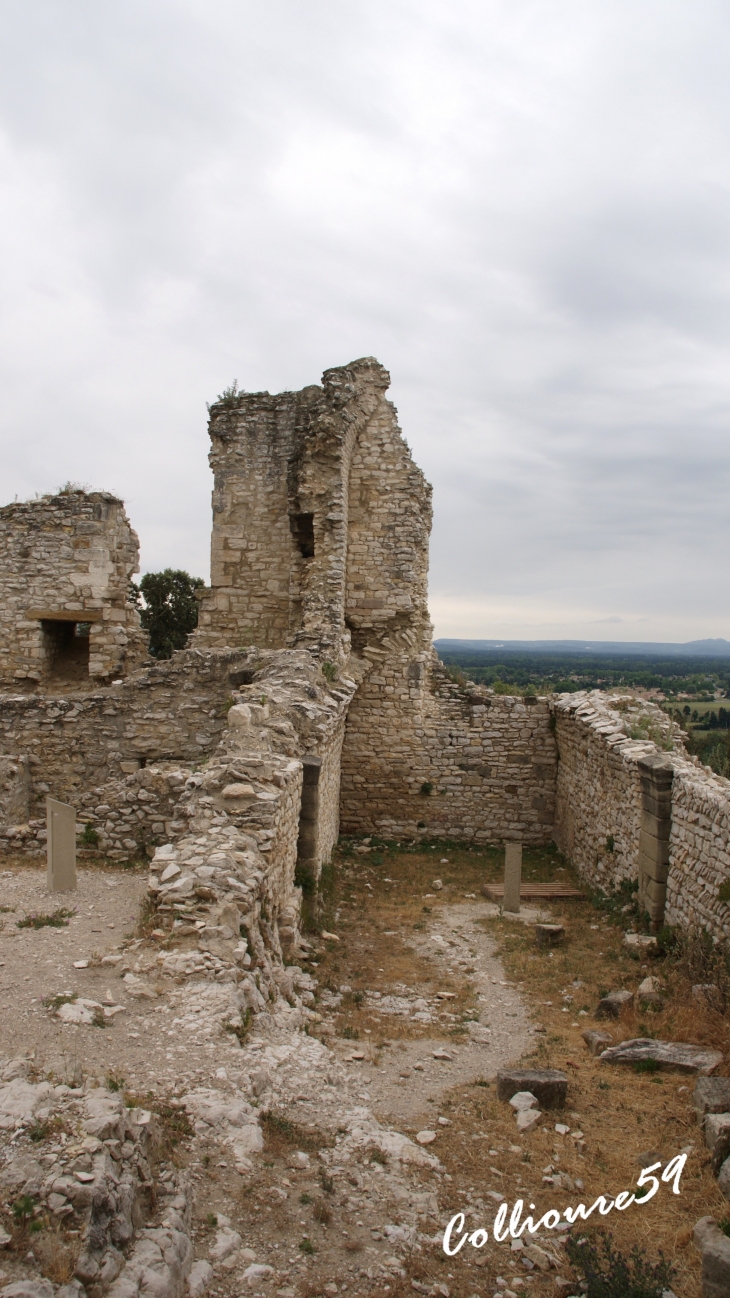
[638,753,674,933]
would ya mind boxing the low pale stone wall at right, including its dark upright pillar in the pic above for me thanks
[549,691,730,938]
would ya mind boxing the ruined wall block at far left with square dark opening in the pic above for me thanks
[0,491,147,689]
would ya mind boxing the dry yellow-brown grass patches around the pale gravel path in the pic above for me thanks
[306,845,717,1298]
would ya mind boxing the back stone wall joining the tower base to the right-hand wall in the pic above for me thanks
[342,654,556,844]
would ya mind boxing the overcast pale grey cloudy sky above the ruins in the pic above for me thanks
[0,0,730,641]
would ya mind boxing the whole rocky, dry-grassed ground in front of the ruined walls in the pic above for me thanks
[0,842,722,1298]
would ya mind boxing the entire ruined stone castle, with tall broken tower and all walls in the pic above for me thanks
[0,358,730,976]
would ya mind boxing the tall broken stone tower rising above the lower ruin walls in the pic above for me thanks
[188,357,431,663]
